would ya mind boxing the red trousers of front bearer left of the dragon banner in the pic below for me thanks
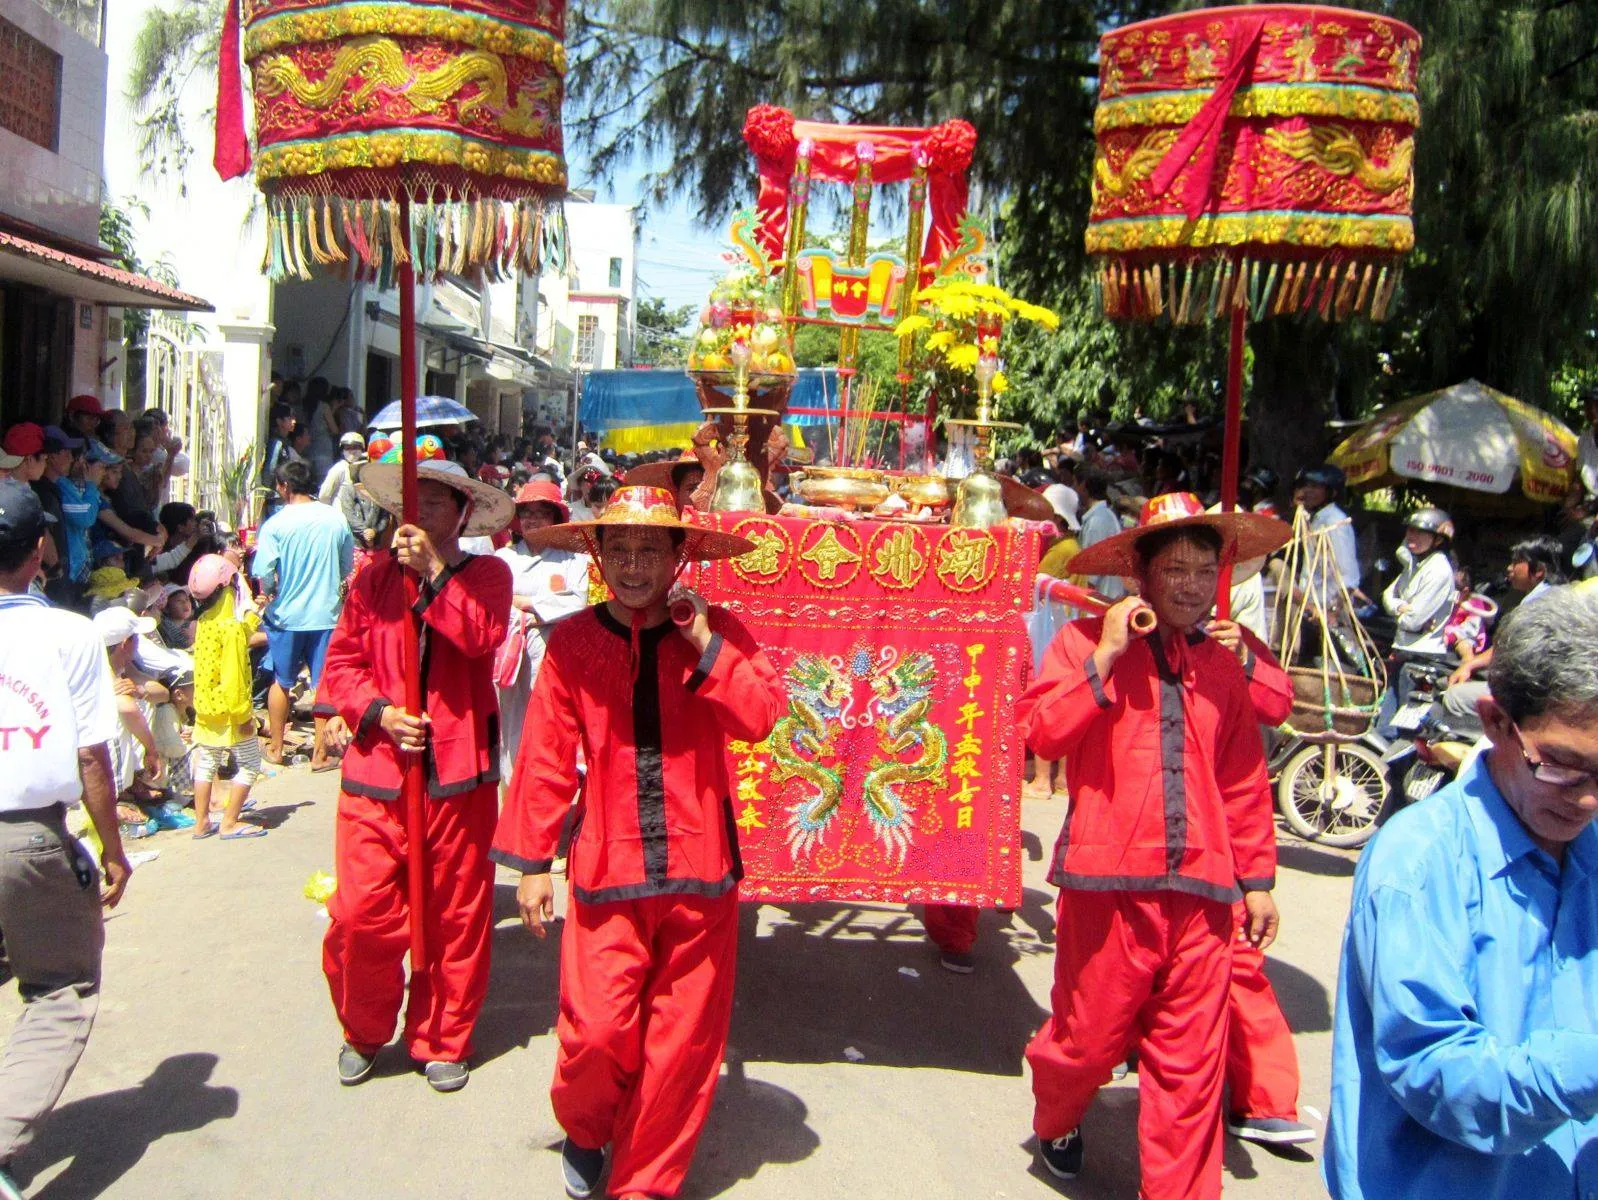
[550,890,738,1197]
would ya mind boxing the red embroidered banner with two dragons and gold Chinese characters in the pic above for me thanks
[695,513,1037,906]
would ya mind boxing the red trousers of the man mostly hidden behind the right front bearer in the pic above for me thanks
[1226,903,1299,1120]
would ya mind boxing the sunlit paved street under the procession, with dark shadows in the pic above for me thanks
[0,767,1354,1200]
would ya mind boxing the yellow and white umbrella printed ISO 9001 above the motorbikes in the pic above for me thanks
[1331,379,1576,503]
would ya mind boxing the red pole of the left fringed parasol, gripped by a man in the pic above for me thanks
[396,193,427,976]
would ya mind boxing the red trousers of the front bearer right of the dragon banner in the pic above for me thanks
[1026,888,1232,1200]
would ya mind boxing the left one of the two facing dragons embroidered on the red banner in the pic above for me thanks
[769,654,853,861]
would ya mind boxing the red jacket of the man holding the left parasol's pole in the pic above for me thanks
[316,553,511,801]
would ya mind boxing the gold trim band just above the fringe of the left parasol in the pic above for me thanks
[256,129,566,187]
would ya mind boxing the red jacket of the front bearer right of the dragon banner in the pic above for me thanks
[1016,618,1277,901]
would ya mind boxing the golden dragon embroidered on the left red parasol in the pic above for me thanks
[256,35,561,137]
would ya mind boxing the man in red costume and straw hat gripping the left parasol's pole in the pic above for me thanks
[316,462,513,1091]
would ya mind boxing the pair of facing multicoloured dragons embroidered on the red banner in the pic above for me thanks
[770,649,948,864]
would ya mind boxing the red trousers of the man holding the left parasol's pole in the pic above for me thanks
[321,783,499,1063]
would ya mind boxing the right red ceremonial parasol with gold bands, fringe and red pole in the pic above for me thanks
[1087,5,1421,615]
